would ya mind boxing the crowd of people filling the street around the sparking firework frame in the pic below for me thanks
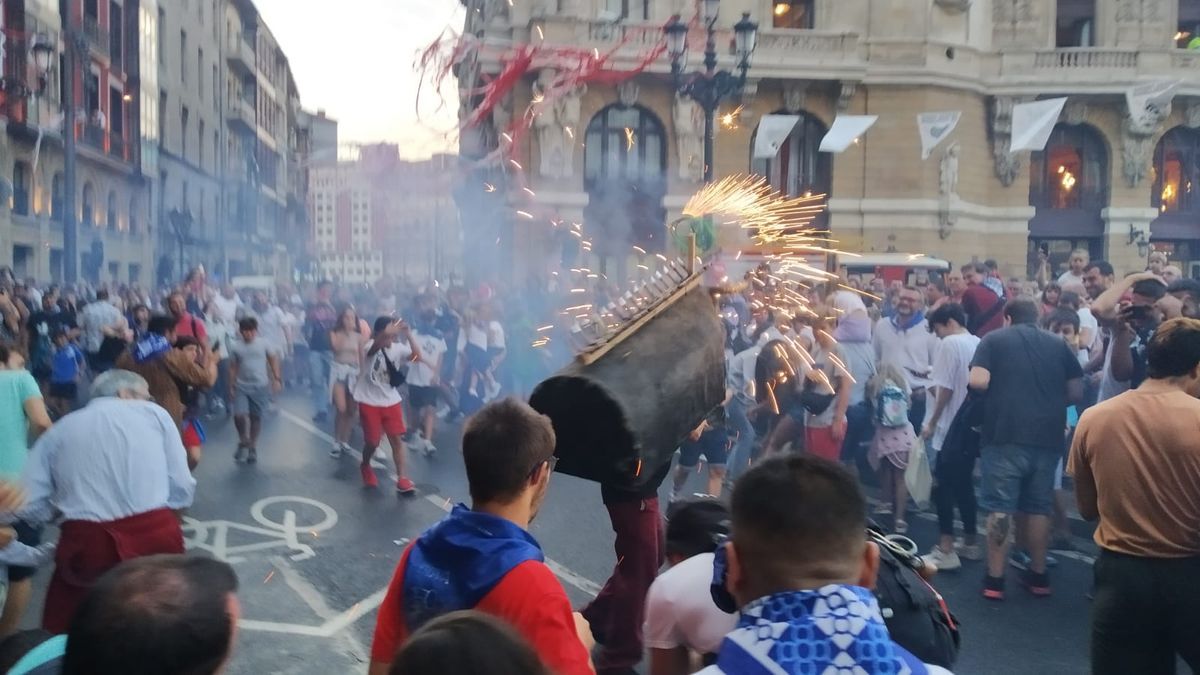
[0,243,1200,675]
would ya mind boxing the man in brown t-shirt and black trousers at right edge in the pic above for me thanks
[1067,318,1200,675]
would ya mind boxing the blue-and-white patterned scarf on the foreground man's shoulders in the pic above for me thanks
[701,585,944,675]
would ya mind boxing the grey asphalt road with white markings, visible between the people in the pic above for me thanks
[25,395,1094,675]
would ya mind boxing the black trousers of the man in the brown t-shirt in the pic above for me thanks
[1092,550,1200,675]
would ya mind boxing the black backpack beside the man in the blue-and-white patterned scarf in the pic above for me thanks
[869,528,961,669]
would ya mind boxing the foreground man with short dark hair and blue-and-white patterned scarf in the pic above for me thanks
[701,455,948,675]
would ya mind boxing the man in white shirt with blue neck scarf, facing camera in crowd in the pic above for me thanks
[872,286,937,429]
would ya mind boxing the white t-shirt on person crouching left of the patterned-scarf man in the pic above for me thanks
[642,554,738,653]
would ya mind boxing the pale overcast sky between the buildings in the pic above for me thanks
[254,0,463,159]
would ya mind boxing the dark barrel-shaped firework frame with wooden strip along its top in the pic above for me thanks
[529,254,725,489]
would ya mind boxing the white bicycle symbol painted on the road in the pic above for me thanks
[184,496,337,563]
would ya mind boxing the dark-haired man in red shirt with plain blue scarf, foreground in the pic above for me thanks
[370,399,592,675]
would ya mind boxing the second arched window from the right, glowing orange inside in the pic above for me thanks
[1030,124,1109,211]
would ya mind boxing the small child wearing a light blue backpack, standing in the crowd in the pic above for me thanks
[866,364,917,534]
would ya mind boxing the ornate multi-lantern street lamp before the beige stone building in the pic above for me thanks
[662,0,758,183]
